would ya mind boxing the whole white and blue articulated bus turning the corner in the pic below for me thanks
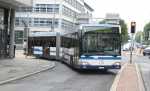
[28,24,121,70]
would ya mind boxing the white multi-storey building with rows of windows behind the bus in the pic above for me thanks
[15,0,91,44]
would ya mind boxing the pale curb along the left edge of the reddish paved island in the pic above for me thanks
[110,63,127,91]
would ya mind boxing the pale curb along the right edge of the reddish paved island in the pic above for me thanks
[135,63,146,91]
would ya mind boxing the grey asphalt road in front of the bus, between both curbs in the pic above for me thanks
[0,62,117,91]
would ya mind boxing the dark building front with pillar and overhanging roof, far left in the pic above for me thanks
[0,0,32,58]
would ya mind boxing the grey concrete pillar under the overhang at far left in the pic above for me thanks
[9,9,15,58]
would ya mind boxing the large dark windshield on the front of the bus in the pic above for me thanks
[82,33,121,55]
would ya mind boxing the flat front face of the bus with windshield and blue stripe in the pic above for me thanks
[76,24,121,70]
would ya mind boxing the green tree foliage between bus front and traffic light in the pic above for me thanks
[120,20,129,44]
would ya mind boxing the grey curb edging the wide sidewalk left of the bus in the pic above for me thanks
[0,63,56,85]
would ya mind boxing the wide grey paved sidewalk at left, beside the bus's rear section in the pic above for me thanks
[0,51,55,85]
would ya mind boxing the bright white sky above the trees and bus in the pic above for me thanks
[85,0,150,31]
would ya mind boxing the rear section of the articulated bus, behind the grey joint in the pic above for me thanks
[28,32,61,59]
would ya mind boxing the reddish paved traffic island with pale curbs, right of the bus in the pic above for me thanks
[110,64,145,91]
